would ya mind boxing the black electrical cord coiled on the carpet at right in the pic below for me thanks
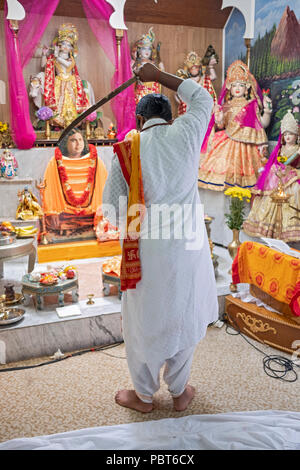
[226,312,300,382]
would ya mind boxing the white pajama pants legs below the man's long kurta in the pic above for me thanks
[125,343,195,403]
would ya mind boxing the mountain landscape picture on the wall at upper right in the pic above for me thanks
[225,0,300,140]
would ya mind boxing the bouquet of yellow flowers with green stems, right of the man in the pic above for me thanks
[224,186,251,230]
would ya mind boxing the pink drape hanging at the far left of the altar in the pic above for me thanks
[4,0,59,149]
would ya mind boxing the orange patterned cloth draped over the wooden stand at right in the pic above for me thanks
[232,241,300,317]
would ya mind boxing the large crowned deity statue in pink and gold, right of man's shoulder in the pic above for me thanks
[198,60,272,191]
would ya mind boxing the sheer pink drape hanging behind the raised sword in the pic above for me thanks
[82,0,136,140]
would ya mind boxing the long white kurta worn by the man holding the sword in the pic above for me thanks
[103,79,218,363]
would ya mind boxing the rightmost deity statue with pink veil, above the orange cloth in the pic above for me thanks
[243,111,300,242]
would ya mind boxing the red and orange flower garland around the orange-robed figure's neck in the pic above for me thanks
[55,145,98,207]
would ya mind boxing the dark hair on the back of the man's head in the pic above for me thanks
[135,93,172,121]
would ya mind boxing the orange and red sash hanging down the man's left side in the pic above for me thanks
[114,133,145,291]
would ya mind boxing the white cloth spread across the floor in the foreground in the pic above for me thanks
[0,409,300,452]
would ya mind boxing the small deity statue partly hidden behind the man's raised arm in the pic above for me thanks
[175,45,219,116]
